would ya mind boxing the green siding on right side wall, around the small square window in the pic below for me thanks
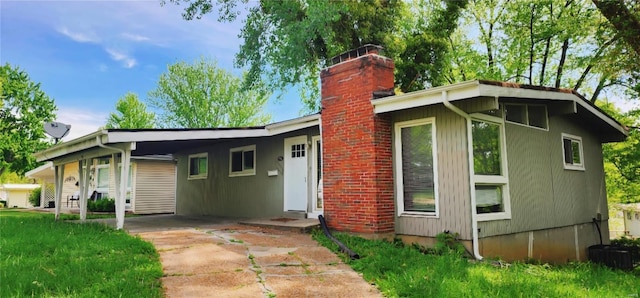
[479,116,608,237]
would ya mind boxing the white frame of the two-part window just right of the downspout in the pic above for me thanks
[469,113,511,221]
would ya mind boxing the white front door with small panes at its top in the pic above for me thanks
[284,136,309,211]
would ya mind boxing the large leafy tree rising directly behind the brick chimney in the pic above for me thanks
[163,0,467,112]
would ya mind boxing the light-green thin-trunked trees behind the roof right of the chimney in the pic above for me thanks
[446,0,640,102]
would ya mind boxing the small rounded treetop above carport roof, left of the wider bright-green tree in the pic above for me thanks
[105,92,156,128]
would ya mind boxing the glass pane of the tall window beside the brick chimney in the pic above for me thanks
[401,124,436,212]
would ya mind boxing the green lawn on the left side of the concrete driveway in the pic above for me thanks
[0,209,163,297]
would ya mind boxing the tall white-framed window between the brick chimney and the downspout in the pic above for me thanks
[395,118,438,216]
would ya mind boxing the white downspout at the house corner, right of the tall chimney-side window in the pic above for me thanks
[442,91,482,260]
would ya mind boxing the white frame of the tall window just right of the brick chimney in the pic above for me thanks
[394,117,440,218]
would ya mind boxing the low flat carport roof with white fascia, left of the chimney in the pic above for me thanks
[35,114,320,163]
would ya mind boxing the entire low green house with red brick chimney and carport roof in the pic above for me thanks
[36,45,626,262]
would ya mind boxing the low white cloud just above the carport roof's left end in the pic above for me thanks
[56,106,107,141]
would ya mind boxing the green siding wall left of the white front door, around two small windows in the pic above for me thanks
[175,128,319,217]
